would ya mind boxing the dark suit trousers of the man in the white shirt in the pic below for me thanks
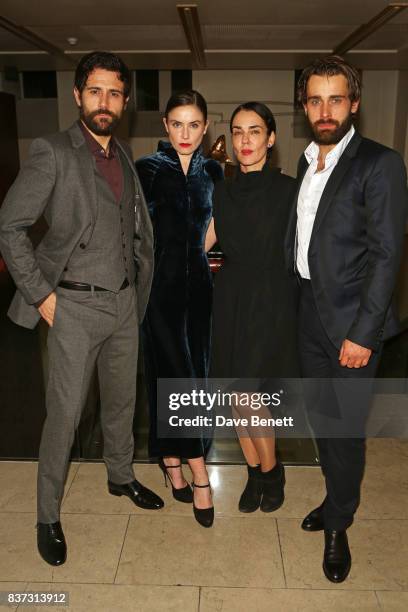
[298,280,381,530]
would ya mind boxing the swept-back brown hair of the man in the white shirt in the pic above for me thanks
[297,55,361,104]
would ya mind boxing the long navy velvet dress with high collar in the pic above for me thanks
[136,141,223,458]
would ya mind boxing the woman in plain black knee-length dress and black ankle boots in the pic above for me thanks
[206,102,298,512]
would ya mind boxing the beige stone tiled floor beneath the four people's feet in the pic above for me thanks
[0,440,408,612]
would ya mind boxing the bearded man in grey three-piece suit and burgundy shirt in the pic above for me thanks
[0,52,163,565]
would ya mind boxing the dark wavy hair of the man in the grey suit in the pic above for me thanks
[74,51,131,98]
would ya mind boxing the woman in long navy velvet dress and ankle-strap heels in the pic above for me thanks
[136,91,223,527]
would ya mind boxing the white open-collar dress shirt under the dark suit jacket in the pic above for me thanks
[296,126,355,280]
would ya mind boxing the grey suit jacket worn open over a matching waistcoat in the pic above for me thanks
[0,123,153,328]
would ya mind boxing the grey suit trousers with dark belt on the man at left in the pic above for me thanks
[37,286,138,523]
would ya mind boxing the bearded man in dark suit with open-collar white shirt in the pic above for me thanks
[286,56,408,582]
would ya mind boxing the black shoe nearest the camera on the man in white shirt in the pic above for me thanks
[323,529,351,582]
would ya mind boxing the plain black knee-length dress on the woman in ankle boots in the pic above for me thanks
[210,164,299,379]
